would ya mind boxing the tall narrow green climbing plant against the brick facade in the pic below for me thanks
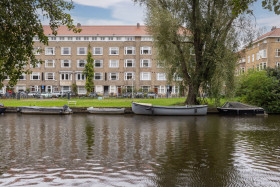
[83,45,94,95]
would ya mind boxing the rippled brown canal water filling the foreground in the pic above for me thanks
[0,114,280,187]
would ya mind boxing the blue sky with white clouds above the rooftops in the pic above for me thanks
[65,0,280,30]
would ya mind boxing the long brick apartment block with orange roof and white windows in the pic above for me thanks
[2,24,182,95]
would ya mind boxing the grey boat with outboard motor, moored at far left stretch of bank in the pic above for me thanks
[18,105,72,115]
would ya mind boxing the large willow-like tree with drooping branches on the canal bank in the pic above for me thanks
[135,0,278,104]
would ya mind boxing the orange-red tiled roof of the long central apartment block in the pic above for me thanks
[43,25,150,36]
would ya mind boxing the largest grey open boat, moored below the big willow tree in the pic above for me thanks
[132,102,208,116]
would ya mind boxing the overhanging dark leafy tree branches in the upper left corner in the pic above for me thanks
[0,0,80,88]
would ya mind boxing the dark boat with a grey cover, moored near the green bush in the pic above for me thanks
[217,102,265,115]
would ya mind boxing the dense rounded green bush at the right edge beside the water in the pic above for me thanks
[236,71,280,112]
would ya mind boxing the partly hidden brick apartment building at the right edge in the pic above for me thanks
[236,27,280,74]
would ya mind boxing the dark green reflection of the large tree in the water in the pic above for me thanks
[152,116,235,186]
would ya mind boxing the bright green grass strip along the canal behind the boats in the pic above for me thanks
[0,98,240,107]
